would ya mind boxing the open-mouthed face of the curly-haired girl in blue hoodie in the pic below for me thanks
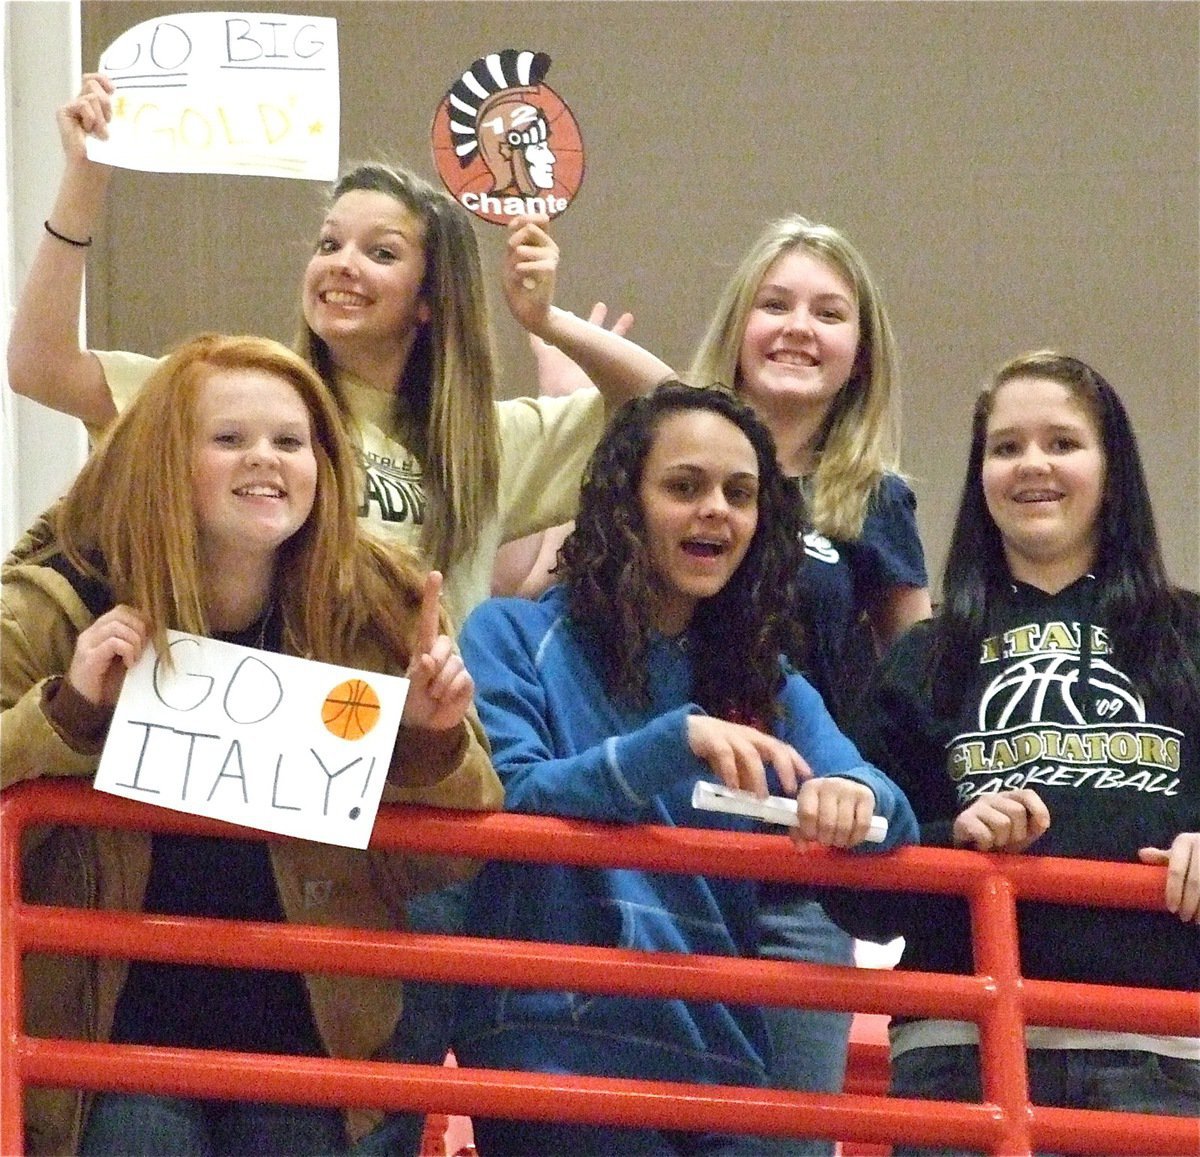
[638,409,758,635]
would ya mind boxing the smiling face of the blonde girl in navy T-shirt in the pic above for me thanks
[738,247,859,419]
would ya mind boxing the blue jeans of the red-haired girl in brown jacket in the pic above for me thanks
[79,1092,349,1157]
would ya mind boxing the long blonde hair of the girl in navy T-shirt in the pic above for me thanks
[689,214,900,540]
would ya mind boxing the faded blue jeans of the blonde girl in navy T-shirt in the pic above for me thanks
[758,900,854,1157]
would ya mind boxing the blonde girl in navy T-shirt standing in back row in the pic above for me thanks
[690,215,930,1157]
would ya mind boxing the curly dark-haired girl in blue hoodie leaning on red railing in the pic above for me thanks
[456,383,916,1157]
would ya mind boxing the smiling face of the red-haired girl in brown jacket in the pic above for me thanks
[192,370,317,568]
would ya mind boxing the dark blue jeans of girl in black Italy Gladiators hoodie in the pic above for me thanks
[890,1044,1200,1157]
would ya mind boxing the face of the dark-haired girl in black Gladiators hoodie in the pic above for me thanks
[982,377,1105,593]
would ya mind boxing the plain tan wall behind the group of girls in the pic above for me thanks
[83,0,1200,586]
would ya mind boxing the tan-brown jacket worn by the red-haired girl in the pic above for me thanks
[0,563,503,1153]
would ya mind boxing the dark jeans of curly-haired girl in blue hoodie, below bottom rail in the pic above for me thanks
[474,1117,766,1157]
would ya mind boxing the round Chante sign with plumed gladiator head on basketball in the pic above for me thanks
[432,48,583,224]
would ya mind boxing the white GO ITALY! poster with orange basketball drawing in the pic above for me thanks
[95,631,408,847]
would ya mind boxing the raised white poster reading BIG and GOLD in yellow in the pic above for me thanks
[88,12,341,181]
